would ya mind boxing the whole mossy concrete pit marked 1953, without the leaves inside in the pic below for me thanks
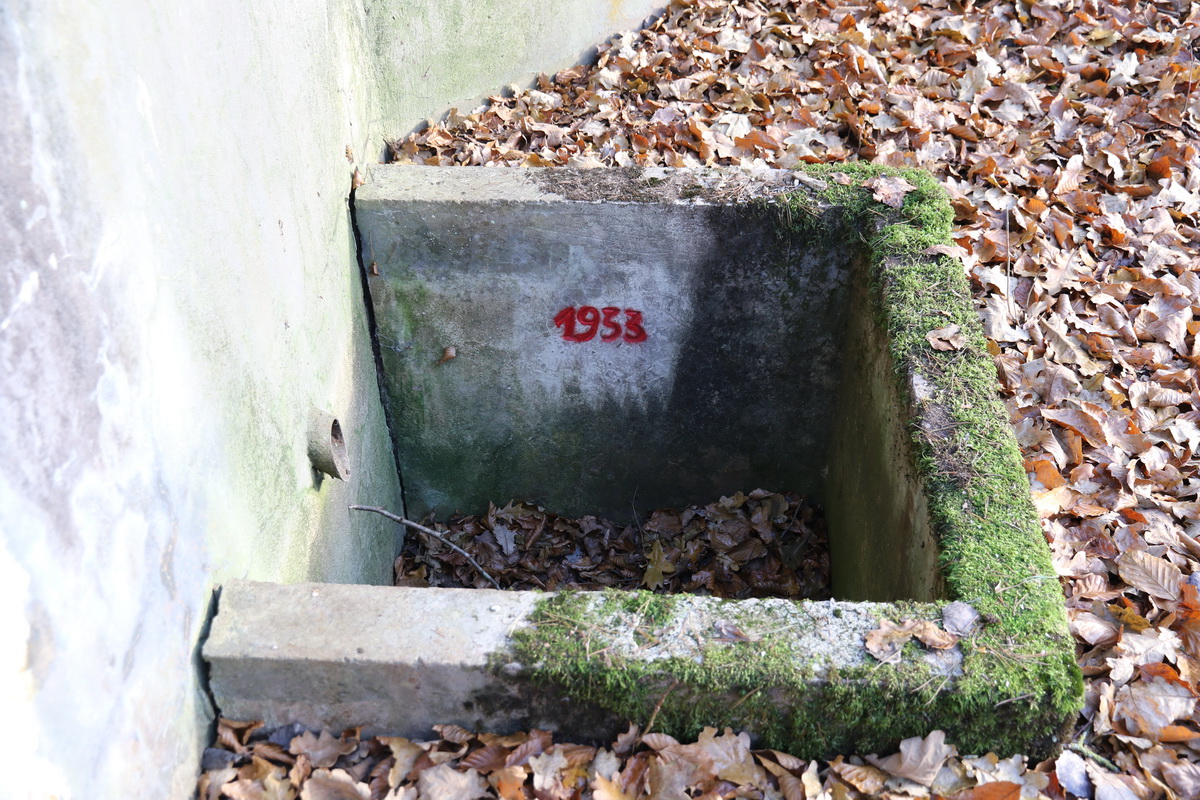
[205,166,1081,756]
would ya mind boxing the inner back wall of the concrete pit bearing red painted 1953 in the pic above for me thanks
[356,167,850,519]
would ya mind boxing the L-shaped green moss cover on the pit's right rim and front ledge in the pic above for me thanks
[501,164,1084,757]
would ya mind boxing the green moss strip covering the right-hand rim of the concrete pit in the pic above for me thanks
[790,164,1082,750]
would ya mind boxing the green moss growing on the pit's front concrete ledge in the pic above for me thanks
[515,593,1072,758]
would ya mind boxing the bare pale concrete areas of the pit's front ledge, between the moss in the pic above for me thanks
[204,581,945,741]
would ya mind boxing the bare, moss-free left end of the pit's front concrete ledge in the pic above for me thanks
[204,581,538,735]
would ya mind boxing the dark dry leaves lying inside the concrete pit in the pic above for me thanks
[396,489,829,599]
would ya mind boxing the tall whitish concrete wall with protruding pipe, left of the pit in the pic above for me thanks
[0,0,649,799]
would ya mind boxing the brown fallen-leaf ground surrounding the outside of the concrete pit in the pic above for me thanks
[202,0,1200,800]
